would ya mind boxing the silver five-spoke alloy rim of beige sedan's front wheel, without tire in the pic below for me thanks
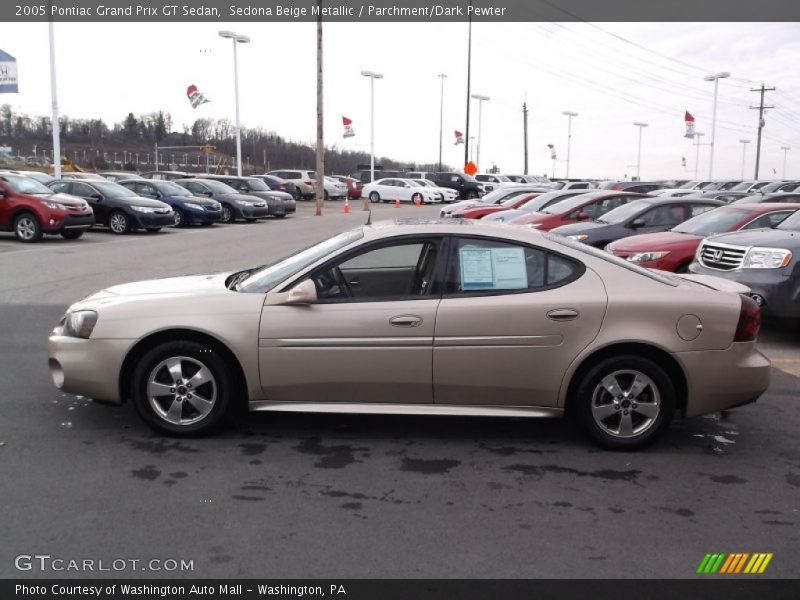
[147,356,217,425]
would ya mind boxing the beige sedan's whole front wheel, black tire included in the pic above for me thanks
[132,341,234,436]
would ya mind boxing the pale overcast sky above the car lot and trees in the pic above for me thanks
[0,22,800,180]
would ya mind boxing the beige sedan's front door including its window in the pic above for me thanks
[259,237,441,403]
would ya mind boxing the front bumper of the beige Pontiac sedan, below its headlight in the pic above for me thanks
[47,330,135,404]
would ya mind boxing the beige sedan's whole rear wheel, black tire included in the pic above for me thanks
[570,355,677,450]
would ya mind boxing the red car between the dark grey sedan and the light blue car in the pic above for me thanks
[510,191,647,231]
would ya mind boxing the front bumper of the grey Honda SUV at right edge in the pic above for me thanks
[689,262,800,318]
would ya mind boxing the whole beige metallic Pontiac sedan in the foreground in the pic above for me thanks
[43,220,770,449]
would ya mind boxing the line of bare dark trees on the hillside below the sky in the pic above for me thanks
[0,104,449,174]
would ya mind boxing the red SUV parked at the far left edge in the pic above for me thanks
[0,173,94,242]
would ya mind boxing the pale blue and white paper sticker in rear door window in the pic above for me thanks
[459,247,528,291]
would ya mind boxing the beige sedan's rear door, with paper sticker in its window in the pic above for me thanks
[433,237,607,407]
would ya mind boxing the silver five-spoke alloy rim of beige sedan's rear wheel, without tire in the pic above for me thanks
[591,369,661,438]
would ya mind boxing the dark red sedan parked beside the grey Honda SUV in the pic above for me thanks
[606,202,800,273]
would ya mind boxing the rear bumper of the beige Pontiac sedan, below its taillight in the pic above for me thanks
[673,342,772,417]
